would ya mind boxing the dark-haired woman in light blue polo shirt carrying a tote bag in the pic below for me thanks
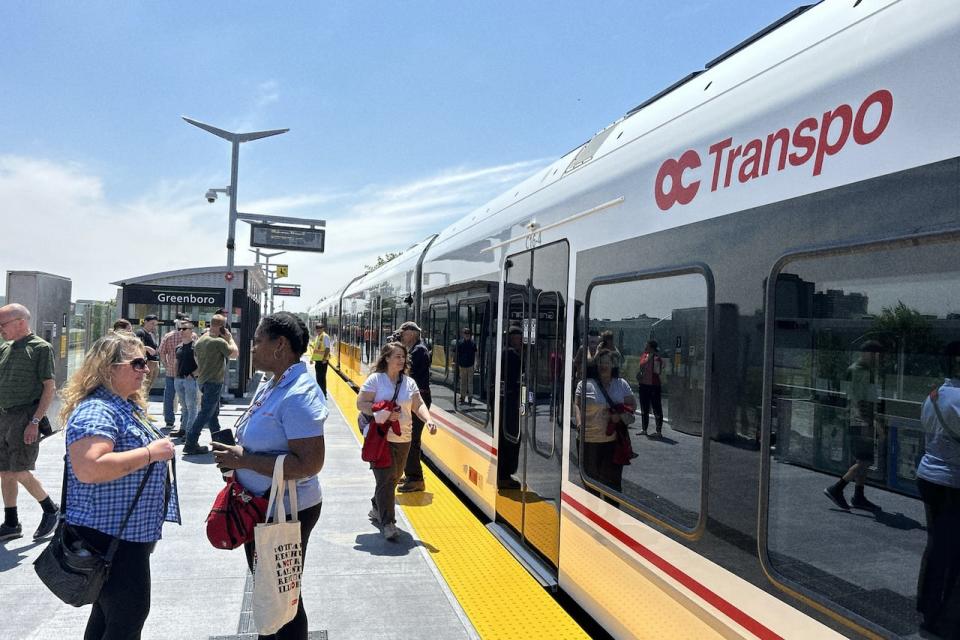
[213,311,327,640]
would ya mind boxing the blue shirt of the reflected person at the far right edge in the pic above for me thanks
[917,378,960,489]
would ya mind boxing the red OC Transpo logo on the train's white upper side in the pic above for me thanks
[653,89,893,211]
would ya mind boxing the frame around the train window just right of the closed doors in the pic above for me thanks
[570,262,716,541]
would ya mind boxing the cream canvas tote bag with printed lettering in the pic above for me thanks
[253,456,303,635]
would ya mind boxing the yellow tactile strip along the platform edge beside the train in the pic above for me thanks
[327,372,589,640]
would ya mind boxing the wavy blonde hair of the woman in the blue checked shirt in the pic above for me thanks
[60,331,147,424]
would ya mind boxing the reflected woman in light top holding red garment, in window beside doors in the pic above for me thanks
[574,349,637,491]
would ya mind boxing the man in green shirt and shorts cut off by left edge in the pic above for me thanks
[0,304,60,541]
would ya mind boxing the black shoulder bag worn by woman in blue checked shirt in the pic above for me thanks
[33,456,153,607]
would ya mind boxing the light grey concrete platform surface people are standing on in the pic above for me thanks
[0,403,477,640]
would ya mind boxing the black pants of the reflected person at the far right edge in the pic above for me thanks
[917,478,960,637]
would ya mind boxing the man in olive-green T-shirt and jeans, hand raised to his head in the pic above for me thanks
[183,314,240,456]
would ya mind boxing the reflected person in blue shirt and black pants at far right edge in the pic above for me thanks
[917,342,960,638]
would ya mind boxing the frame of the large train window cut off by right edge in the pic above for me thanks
[757,229,960,636]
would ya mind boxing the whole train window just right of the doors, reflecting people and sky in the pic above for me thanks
[572,267,712,535]
